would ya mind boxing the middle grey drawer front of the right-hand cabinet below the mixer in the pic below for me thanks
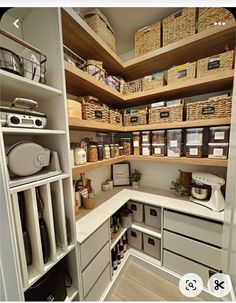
[164,230,221,270]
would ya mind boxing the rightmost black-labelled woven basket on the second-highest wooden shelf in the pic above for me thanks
[197,51,234,77]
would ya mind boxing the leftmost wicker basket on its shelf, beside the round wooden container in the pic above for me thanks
[79,96,109,123]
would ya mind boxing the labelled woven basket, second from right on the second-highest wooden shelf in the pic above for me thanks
[168,62,196,84]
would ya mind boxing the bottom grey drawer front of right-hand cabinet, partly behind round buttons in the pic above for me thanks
[163,249,218,287]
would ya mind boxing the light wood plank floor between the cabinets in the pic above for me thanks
[105,261,202,301]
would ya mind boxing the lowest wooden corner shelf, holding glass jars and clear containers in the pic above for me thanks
[72,156,228,176]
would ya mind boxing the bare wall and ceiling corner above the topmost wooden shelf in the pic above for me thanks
[80,7,180,55]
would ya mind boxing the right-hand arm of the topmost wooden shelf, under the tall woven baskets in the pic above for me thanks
[122,22,235,80]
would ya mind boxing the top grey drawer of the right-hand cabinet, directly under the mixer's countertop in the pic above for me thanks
[164,210,223,246]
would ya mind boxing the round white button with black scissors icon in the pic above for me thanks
[207,273,232,298]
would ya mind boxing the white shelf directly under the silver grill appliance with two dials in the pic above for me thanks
[2,127,66,135]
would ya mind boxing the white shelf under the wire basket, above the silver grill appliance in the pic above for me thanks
[0,69,62,101]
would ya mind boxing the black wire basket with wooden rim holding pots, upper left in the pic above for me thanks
[0,29,47,84]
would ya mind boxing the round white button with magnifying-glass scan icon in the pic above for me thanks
[179,273,203,298]
